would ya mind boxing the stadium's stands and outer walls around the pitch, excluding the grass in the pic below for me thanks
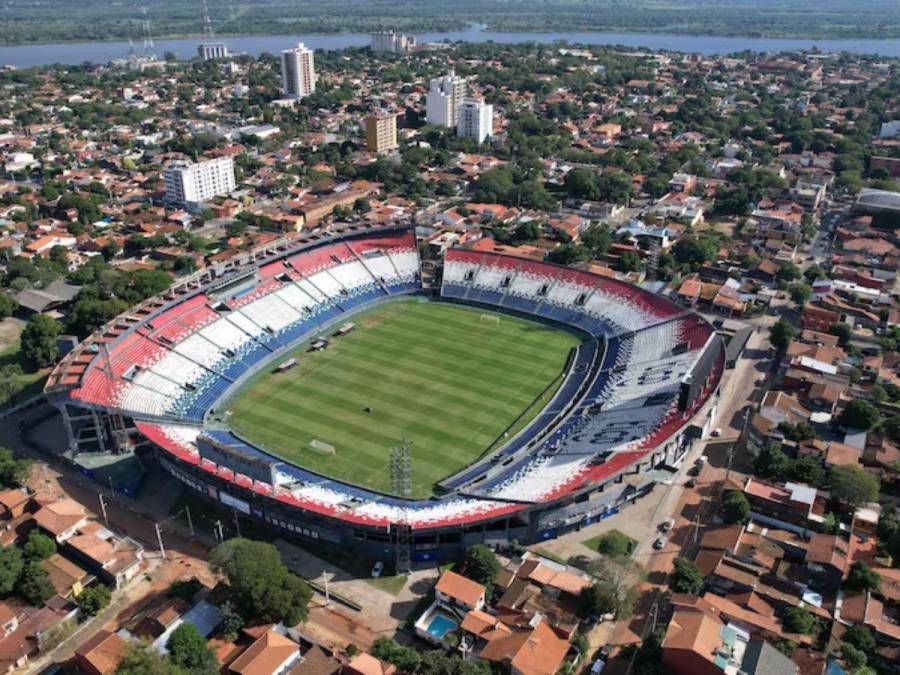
[46,226,724,562]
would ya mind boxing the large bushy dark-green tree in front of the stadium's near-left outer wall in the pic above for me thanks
[209,538,312,626]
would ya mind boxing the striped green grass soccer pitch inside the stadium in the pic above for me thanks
[226,301,579,497]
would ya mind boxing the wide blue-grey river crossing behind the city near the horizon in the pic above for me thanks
[0,28,900,68]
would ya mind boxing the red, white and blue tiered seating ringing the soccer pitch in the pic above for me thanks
[50,231,724,552]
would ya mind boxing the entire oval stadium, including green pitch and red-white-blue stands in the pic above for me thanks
[46,226,724,564]
